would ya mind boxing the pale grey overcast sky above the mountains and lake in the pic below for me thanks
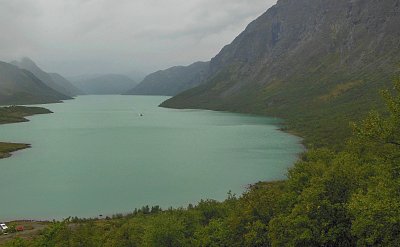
[0,0,276,76]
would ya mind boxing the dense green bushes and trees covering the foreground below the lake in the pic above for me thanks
[6,78,400,246]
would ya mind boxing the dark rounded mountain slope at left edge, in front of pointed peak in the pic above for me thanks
[0,62,69,105]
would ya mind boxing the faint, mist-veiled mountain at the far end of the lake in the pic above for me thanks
[70,74,137,94]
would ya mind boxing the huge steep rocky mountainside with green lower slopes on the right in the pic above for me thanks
[161,0,400,145]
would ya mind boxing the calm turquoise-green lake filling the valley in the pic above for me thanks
[0,95,303,221]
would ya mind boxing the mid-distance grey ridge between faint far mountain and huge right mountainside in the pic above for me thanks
[126,62,210,96]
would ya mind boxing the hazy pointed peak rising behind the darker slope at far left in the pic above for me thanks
[11,57,78,97]
